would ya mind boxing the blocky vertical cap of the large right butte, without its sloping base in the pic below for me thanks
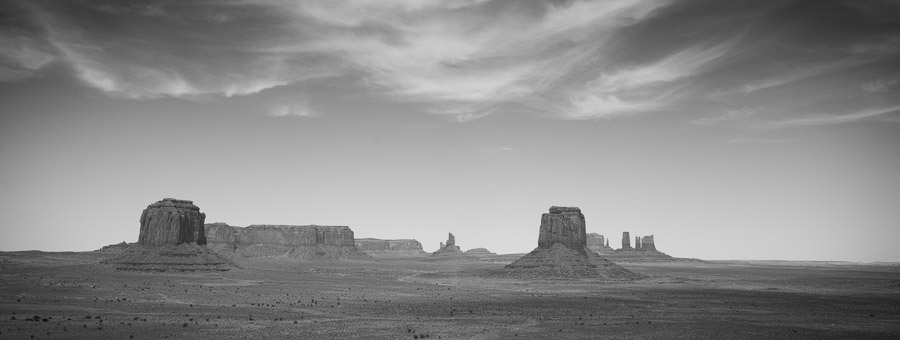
[538,206,587,249]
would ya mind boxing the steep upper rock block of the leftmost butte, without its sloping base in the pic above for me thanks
[138,198,206,246]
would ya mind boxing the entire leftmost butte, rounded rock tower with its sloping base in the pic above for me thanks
[101,198,232,272]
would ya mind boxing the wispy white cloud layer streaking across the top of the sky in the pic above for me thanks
[0,0,900,126]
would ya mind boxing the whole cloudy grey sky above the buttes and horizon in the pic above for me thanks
[0,0,900,262]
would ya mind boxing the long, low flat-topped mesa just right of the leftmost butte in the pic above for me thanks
[206,223,367,259]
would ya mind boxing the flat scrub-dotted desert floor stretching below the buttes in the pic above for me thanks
[0,252,900,339]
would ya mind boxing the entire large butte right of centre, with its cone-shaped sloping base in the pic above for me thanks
[505,207,637,279]
